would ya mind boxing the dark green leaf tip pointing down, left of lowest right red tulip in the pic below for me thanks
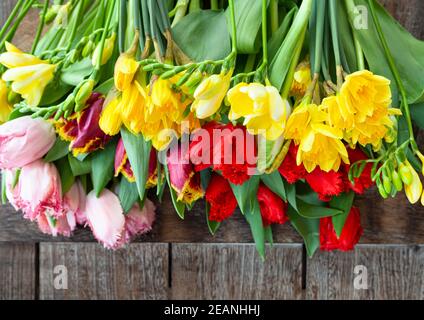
[288,206,319,257]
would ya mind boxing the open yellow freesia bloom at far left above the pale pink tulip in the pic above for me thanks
[0,43,56,107]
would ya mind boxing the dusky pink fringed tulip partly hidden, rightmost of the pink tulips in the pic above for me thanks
[125,199,156,242]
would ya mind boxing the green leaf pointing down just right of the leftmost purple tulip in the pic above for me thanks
[91,140,117,197]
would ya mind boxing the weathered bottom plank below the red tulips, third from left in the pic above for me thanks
[172,244,303,300]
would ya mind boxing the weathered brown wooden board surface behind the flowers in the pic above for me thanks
[0,0,424,299]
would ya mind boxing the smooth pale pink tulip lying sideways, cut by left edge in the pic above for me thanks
[0,116,56,169]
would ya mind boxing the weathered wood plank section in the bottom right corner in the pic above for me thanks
[306,245,424,300]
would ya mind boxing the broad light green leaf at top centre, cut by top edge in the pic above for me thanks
[227,0,269,54]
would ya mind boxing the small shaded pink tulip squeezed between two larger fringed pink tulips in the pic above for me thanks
[63,181,87,231]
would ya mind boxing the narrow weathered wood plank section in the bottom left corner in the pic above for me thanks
[0,243,37,300]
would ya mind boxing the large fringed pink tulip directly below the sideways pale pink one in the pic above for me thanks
[6,160,63,221]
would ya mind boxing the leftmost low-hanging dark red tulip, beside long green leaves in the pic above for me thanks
[206,174,237,222]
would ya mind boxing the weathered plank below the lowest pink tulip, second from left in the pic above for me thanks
[40,243,168,300]
